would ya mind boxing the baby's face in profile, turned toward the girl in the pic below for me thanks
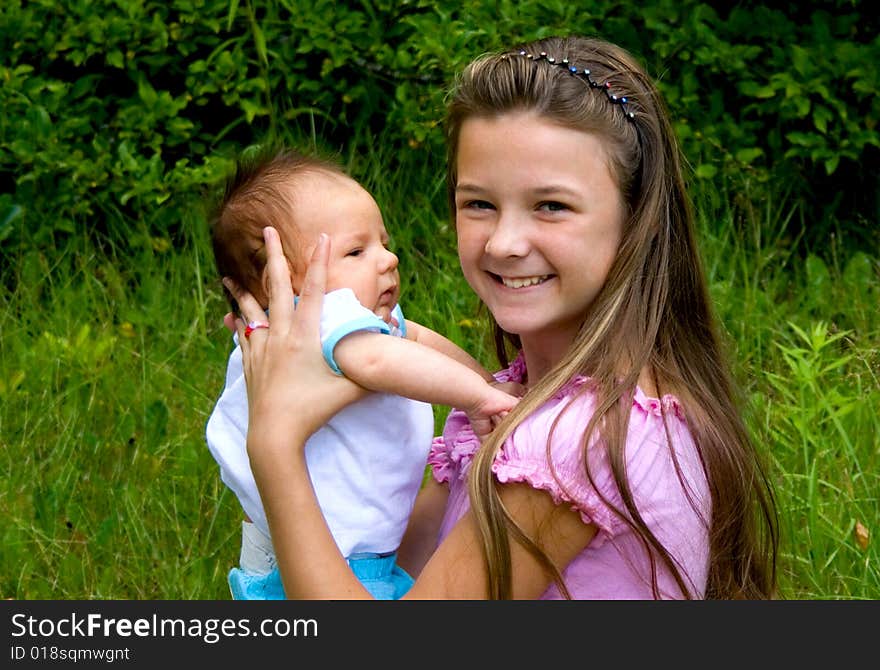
[292,172,400,323]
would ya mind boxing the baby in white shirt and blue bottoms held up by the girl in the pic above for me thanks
[206,150,517,599]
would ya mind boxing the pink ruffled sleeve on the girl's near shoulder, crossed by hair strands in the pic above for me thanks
[493,380,710,547]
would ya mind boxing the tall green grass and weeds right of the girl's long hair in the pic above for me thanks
[701,181,880,599]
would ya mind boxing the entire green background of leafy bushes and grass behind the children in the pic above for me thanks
[0,0,880,599]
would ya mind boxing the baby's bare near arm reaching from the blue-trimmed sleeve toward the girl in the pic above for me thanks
[333,332,518,436]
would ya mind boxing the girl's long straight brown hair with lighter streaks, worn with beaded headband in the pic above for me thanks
[446,37,778,599]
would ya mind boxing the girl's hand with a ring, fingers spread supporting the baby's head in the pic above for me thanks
[223,228,366,460]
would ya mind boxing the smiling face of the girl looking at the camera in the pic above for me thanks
[455,112,624,362]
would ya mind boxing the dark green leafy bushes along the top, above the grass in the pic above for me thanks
[0,0,880,256]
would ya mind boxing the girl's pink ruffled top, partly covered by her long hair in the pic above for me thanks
[429,356,711,600]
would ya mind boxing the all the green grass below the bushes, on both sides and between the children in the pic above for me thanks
[0,155,880,599]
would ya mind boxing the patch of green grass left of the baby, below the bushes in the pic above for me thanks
[0,217,236,598]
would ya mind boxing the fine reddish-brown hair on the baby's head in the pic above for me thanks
[210,144,348,312]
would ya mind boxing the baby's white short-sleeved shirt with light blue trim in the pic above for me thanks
[205,289,434,557]
